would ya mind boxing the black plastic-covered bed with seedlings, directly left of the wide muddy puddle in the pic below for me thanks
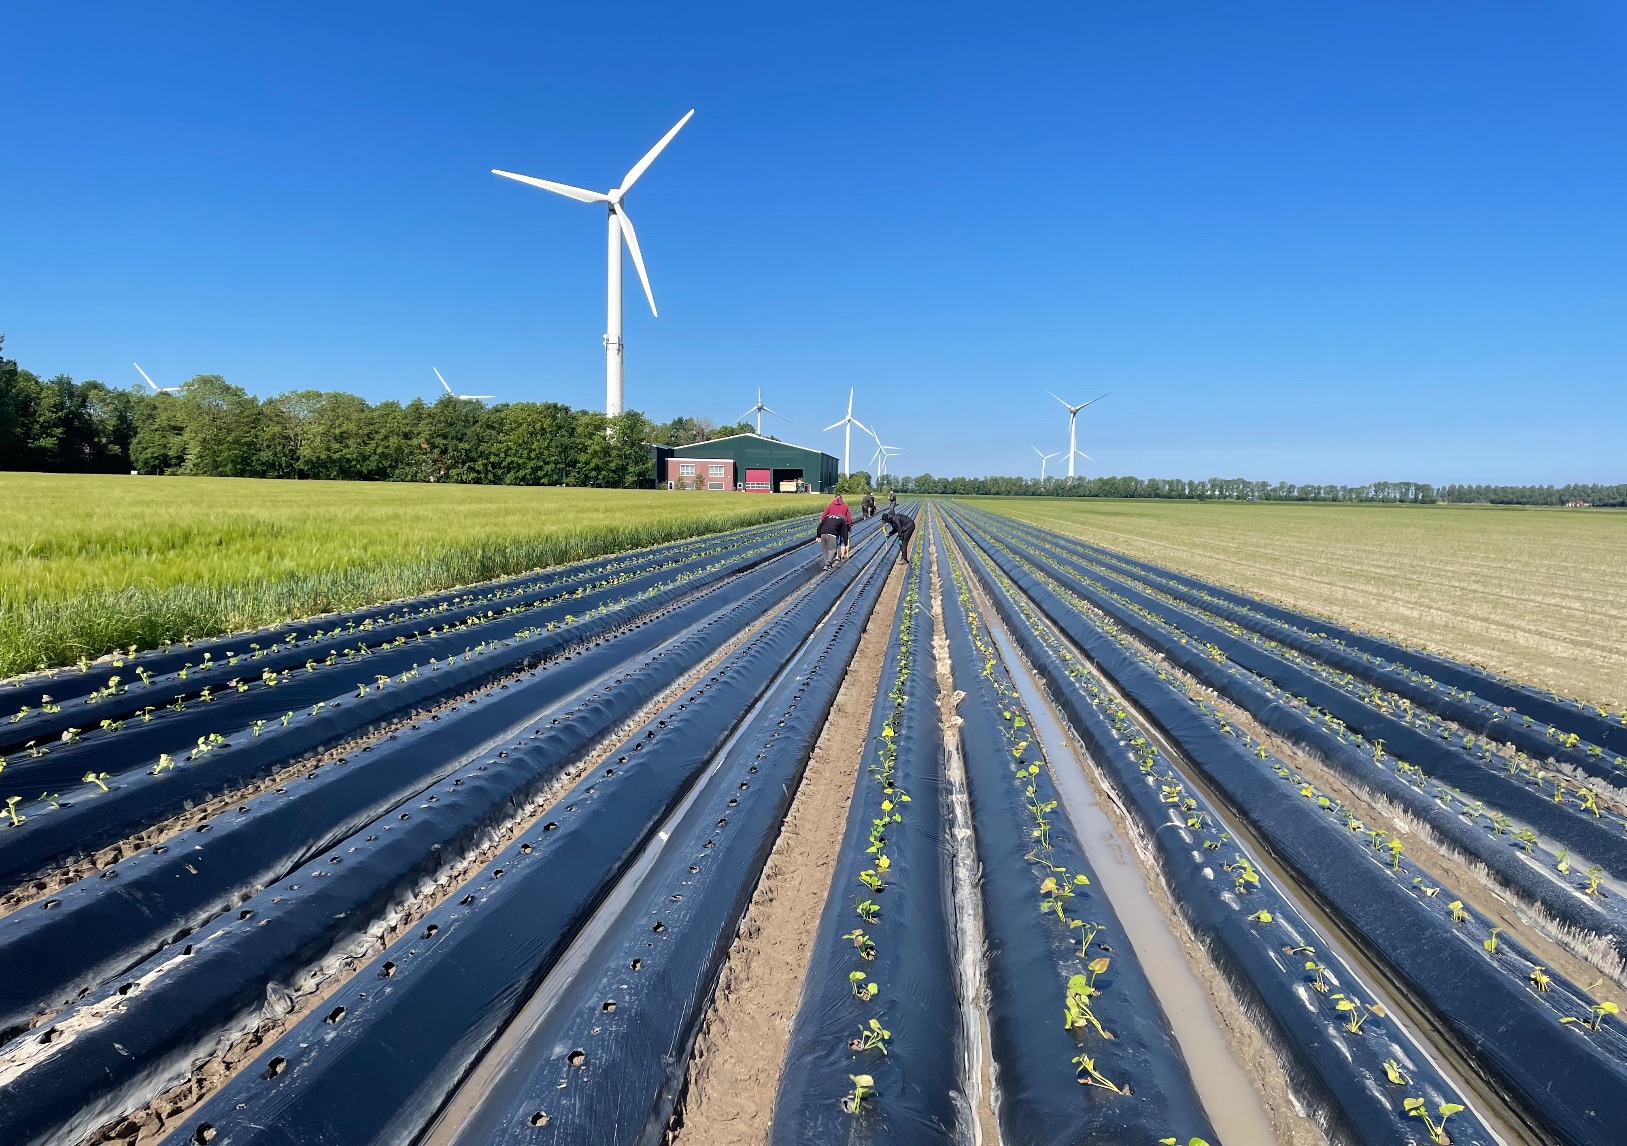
[937,524,1217,1146]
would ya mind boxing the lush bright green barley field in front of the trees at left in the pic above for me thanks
[0,474,823,676]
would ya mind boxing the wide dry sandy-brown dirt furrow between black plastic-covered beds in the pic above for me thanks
[667,566,903,1146]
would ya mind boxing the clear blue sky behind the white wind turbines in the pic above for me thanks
[0,0,1627,482]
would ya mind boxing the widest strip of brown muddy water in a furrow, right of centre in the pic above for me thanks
[991,627,1277,1146]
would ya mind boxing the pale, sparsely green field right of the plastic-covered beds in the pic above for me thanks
[970,498,1627,706]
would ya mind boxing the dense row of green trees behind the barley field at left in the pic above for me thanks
[0,340,750,488]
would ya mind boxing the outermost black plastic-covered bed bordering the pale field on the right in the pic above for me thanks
[995,524,1627,781]
